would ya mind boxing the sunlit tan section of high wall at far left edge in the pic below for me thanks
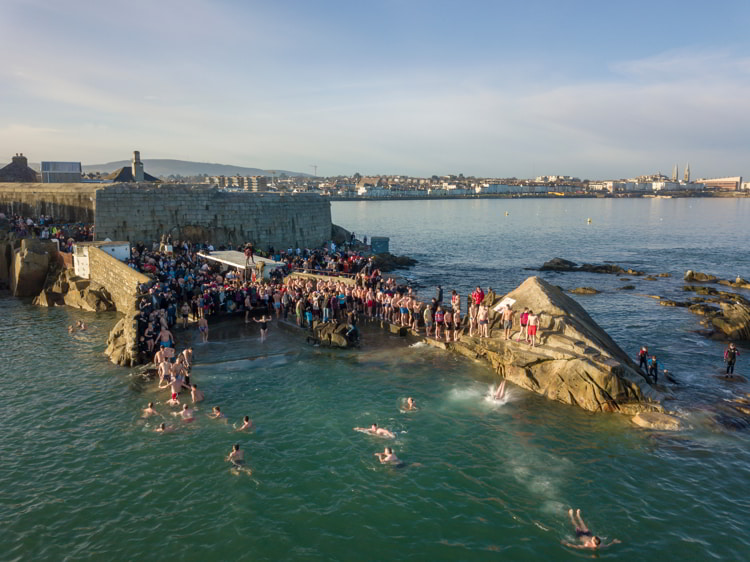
[0,183,102,223]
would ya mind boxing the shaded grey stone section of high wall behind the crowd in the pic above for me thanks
[95,184,331,248]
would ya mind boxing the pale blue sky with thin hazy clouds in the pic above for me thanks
[0,0,750,179]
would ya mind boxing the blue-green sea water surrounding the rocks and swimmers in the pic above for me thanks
[0,199,750,561]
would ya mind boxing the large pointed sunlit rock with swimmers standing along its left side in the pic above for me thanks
[448,277,662,414]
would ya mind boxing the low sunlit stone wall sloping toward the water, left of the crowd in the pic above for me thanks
[88,246,150,315]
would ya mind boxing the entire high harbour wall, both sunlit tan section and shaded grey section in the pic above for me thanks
[0,183,331,248]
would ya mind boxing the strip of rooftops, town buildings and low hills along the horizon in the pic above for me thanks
[0,150,750,195]
